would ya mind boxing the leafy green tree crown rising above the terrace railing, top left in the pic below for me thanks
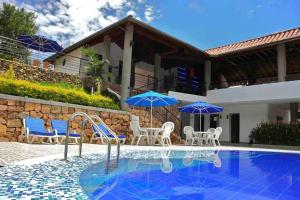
[0,3,37,39]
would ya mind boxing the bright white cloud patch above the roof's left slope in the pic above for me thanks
[5,0,159,46]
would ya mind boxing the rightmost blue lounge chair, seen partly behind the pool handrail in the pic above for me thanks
[90,123,127,144]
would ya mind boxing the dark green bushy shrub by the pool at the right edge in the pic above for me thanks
[249,122,300,145]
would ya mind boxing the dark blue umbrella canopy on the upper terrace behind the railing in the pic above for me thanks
[18,35,63,52]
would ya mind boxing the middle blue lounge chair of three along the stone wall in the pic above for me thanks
[51,119,80,144]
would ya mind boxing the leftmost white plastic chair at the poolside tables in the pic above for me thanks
[130,116,150,145]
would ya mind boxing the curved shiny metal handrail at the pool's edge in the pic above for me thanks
[64,112,120,171]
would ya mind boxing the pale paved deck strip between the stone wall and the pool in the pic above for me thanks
[0,142,300,166]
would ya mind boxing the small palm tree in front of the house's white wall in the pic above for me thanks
[82,48,112,93]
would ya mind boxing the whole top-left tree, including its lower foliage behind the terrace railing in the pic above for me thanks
[0,3,37,61]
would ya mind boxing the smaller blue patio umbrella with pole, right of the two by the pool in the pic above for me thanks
[178,101,223,131]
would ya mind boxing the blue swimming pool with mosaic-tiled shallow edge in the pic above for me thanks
[0,150,300,200]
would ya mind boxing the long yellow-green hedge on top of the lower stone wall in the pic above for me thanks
[0,77,119,109]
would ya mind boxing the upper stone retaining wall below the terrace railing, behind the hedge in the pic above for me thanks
[0,59,80,84]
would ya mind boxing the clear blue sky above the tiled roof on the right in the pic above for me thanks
[151,0,300,49]
